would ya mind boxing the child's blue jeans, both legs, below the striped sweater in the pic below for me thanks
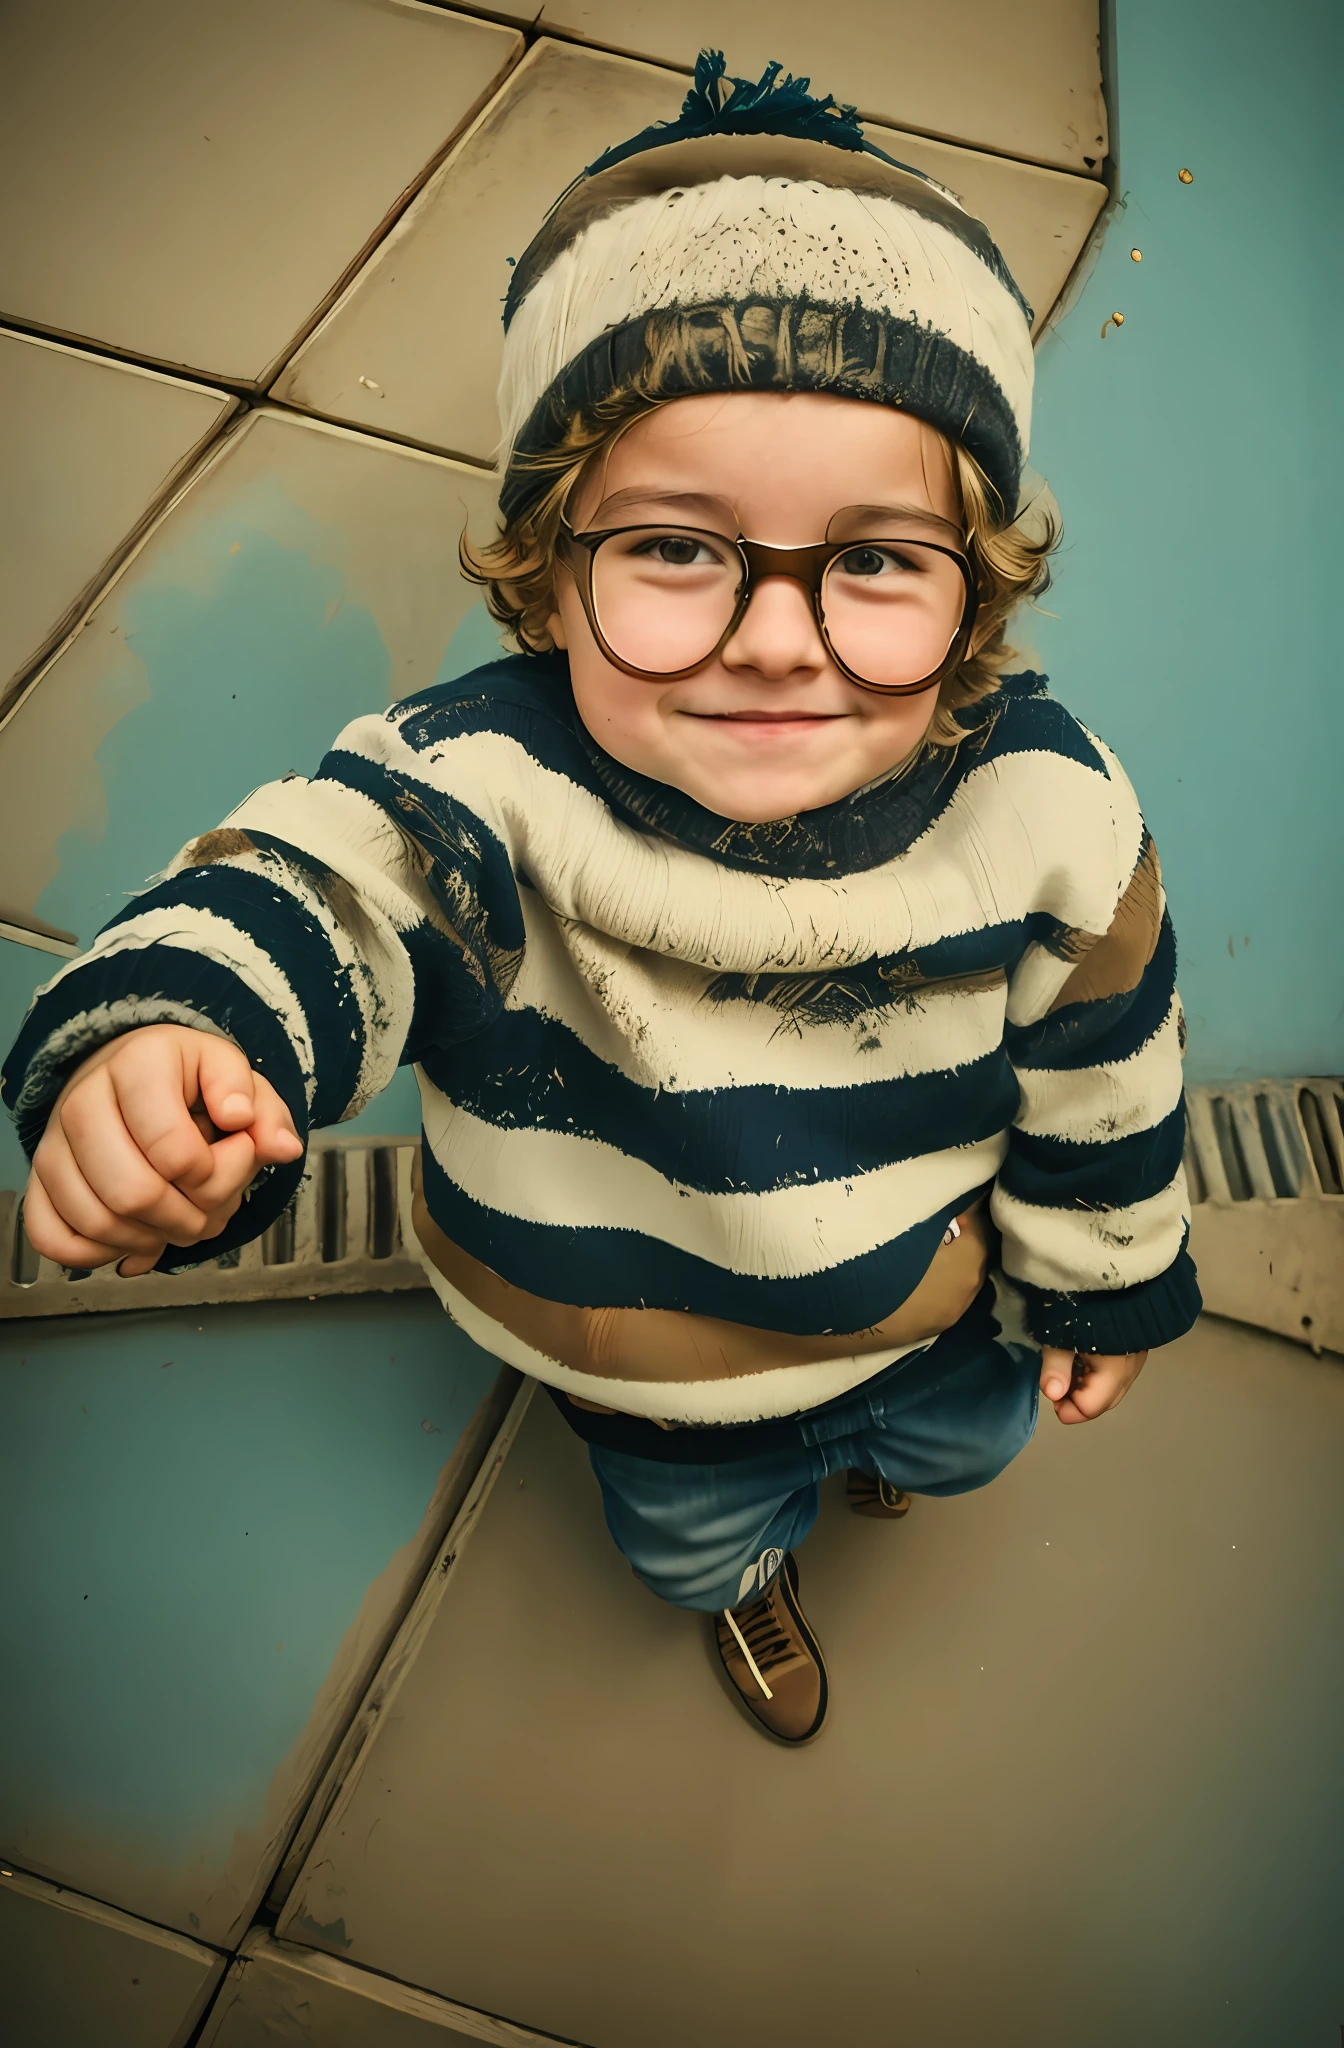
[588,1337,1041,1614]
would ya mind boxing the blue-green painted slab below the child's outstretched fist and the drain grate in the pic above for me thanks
[0,1294,498,1944]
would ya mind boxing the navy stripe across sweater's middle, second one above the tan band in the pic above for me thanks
[420,1010,1018,1196]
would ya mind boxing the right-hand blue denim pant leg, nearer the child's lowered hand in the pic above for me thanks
[840,1341,1041,1497]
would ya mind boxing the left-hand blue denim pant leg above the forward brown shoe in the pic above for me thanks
[588,1444,822,1614]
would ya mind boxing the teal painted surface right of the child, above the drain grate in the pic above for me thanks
[1020,0,1344,1081]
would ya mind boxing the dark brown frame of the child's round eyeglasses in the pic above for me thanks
[559,516,979,696]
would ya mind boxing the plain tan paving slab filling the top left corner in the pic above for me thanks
[0,0,522,385]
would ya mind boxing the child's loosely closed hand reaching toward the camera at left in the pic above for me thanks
[23,1024,303,1278]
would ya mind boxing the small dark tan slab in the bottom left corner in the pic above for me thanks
[0,1872,225,2048]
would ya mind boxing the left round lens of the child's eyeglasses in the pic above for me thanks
[592,526,744,676]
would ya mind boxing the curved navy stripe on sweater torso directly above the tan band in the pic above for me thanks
[424,1145,975,1335]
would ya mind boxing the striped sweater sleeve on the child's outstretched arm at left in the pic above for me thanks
[2,707,522,1270]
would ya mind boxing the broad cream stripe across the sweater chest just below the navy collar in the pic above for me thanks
[370,719,1143,973]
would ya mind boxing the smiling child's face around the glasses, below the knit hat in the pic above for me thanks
[551,391,961,823]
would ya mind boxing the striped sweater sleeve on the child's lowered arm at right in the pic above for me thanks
[992,790,1201,1354]
